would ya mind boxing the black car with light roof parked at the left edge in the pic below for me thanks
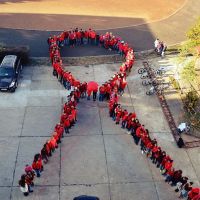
[0,55,22,92]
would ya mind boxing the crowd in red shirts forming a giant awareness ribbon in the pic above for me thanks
[19,29,200,200]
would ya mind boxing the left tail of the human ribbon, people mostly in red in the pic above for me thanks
[18,94,79,196]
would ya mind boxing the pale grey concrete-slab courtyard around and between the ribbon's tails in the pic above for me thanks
[0,58,200,200]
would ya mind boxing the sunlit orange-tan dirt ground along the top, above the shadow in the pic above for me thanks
[0,0,187,21]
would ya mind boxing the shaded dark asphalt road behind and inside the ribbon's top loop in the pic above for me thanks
[0,28,154,57]
